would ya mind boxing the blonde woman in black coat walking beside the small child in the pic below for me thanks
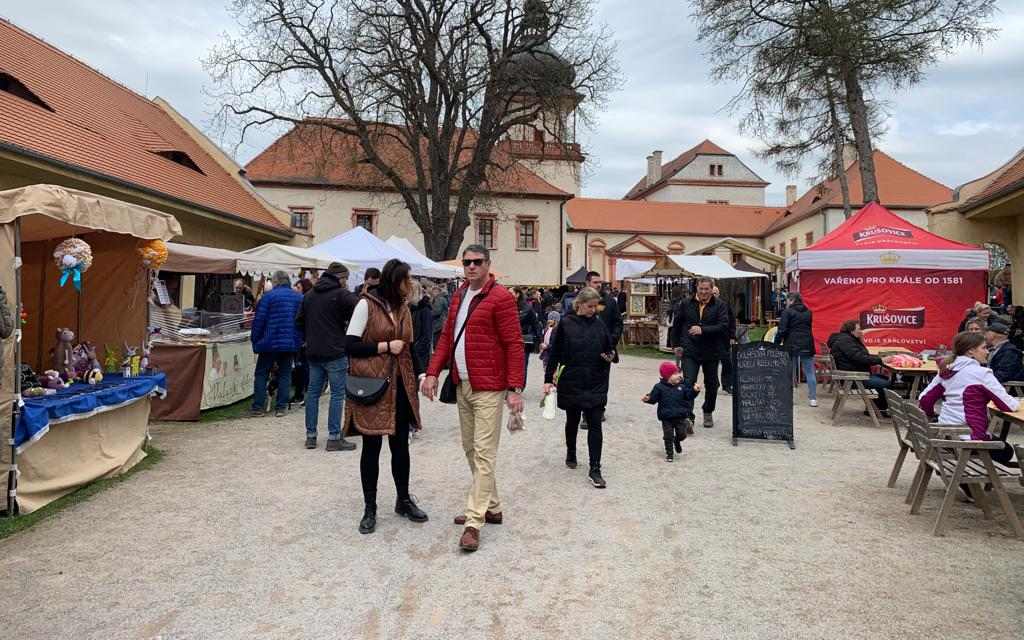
[544,288,614,488]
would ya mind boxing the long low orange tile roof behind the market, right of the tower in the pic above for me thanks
[565,198,785,238]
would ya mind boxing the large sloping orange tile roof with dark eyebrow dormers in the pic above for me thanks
[0,19,289,233]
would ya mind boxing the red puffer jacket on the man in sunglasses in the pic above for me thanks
[427,275,523,391]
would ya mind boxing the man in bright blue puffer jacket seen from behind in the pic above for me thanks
[250,271,302,418]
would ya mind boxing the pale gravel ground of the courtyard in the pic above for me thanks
[0,357,1024,640]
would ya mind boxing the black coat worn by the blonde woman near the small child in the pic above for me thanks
[544,314,614,411]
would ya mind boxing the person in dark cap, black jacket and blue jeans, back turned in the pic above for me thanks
[295,262,358,452]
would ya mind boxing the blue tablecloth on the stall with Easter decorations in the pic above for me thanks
[14,374,167,453]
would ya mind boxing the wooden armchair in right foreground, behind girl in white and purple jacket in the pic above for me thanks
[903,404,1024,538]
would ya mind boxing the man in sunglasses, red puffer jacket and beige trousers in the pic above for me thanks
[422,245,523,551]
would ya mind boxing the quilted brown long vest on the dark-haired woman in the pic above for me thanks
[345,293,423,435]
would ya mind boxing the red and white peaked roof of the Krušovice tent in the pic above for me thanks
[786,203,988,271]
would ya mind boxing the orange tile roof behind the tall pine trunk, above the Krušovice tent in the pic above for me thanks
[767,150,952,233]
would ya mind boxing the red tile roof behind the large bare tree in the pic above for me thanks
[246,121,572,200]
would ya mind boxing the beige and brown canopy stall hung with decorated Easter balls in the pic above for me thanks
[0,184,181,515]
